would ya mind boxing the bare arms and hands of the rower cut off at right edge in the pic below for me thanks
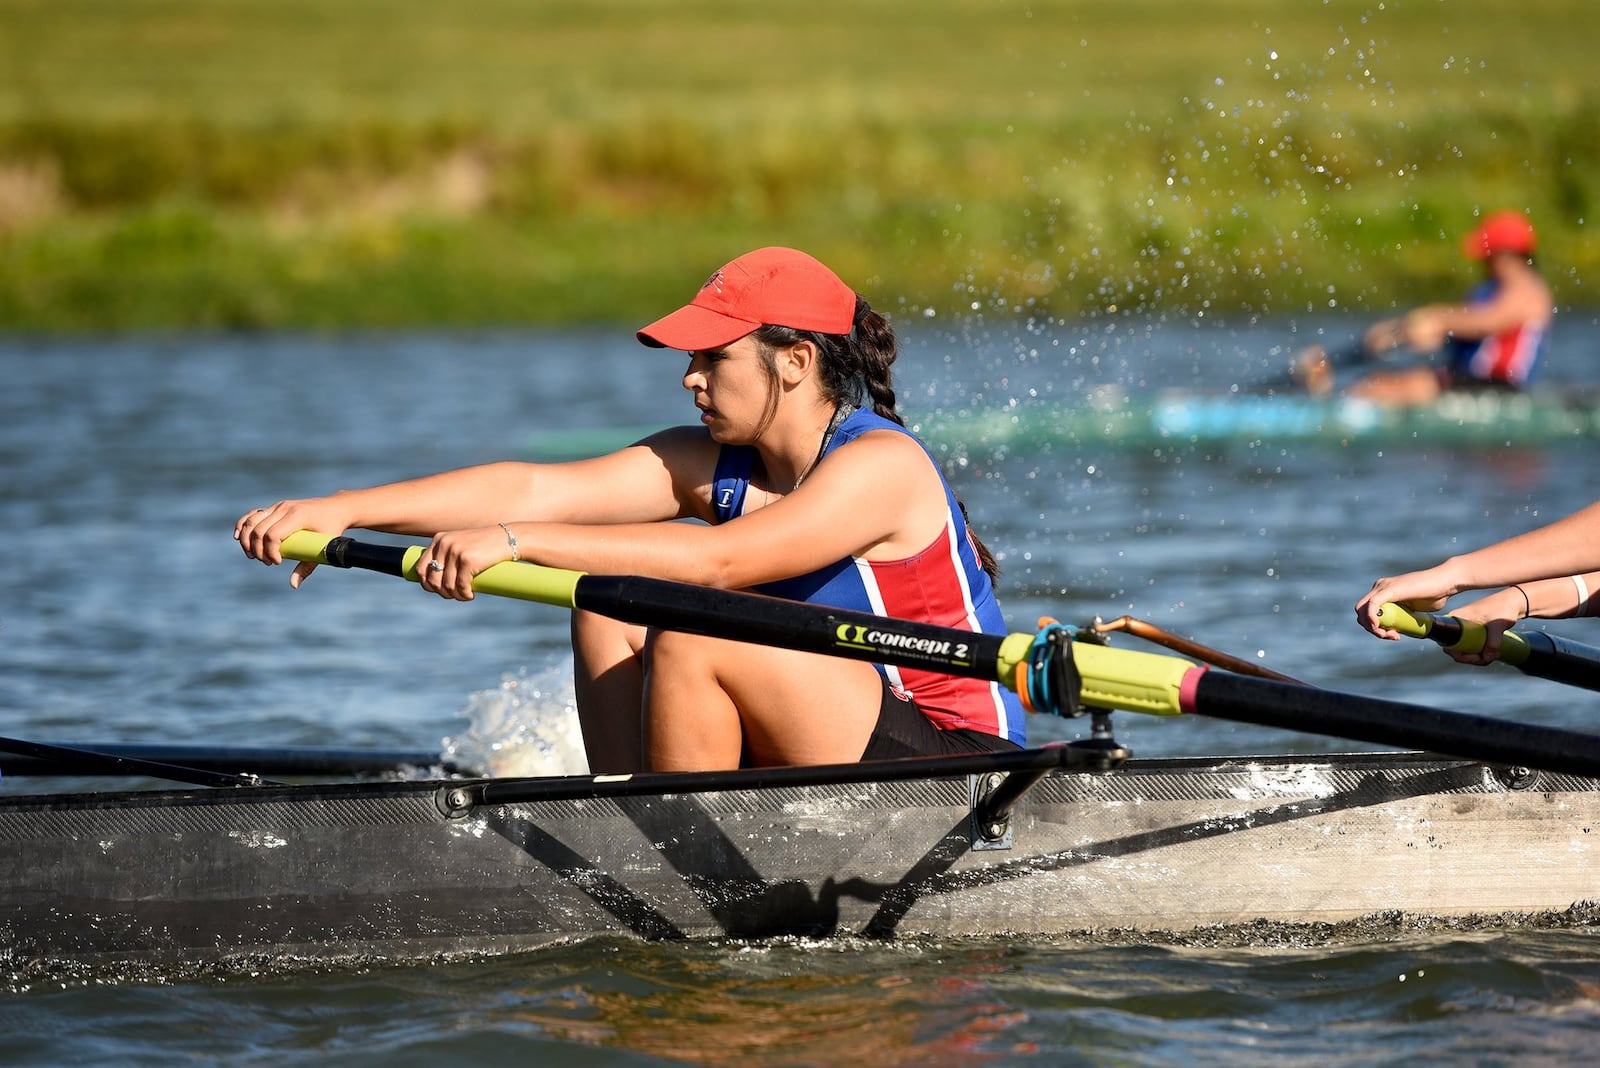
[1355,502,1600,664]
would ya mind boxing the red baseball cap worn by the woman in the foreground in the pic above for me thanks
[638,248,856,352]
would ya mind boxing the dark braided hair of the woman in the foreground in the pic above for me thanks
[752,293,1000,582]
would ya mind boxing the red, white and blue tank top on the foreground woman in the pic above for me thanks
[712,409,1027,745]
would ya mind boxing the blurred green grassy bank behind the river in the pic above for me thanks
[0,0,1600,331]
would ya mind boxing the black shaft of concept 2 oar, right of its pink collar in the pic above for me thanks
[1190,671,1600,777]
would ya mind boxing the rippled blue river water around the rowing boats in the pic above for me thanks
[0,312,1600,1065]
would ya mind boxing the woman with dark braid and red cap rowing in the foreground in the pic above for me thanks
[234,248,1026,772]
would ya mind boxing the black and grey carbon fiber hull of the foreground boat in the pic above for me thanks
[0,751,1600,967]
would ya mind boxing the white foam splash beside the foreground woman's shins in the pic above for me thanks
[443,662,589,777]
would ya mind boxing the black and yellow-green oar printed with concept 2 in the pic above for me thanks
[282,531,1600,777]
